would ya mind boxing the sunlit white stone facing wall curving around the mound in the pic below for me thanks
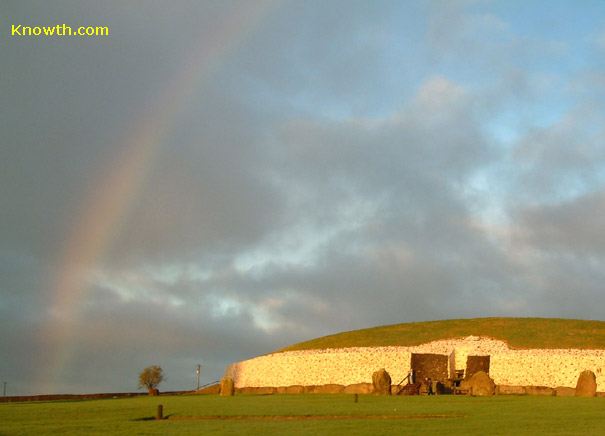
[225,336,605,390]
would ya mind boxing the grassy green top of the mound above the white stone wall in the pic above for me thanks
[277,318,605,352]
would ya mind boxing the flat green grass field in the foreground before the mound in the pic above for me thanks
[0,395,605,436]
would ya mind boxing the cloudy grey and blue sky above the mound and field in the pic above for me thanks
[0,0,605,395]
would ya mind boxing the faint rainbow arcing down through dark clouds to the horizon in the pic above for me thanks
[37,0,277,393]
